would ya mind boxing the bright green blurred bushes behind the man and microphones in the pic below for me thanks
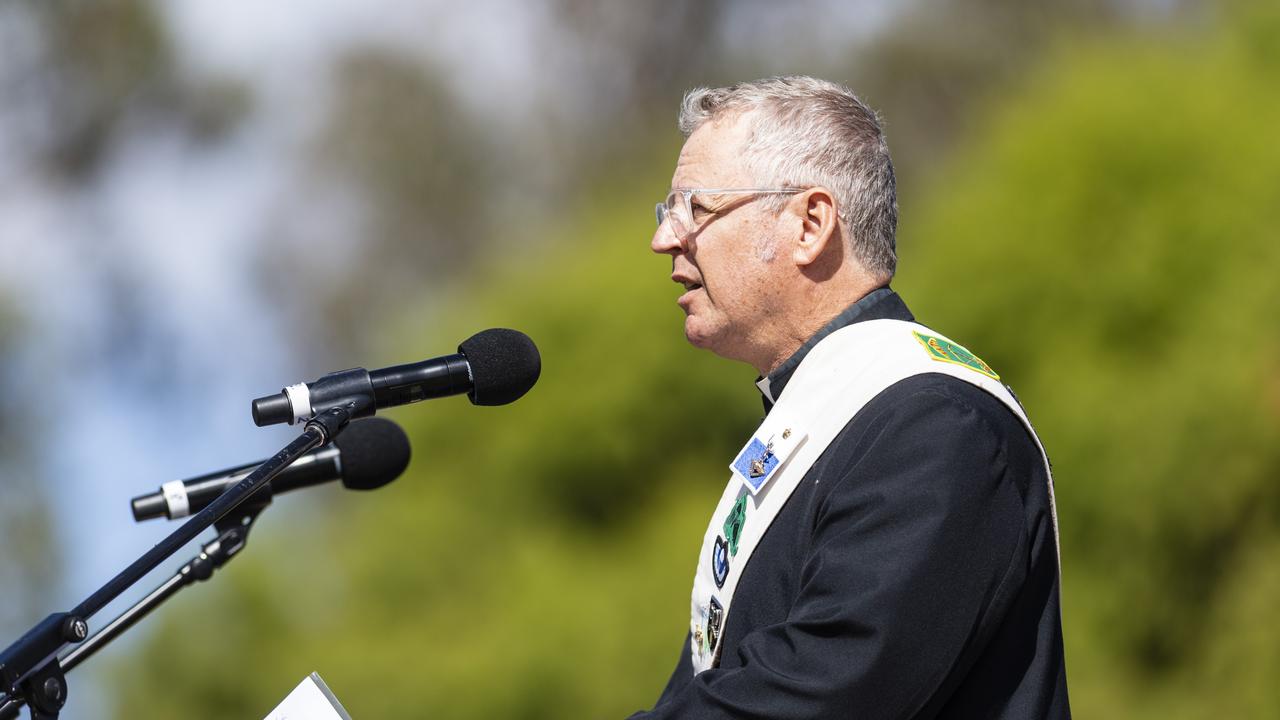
[107,4,1280,719]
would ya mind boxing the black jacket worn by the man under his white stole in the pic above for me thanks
[632,288,1070,720]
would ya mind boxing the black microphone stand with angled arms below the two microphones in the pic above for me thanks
[0,400,355,720]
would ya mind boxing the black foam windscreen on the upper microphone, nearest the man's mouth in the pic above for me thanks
[458,328,543,405]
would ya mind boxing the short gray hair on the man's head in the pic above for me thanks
[680,76,897,282]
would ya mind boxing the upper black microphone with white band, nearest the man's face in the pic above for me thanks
[253,328,543,427]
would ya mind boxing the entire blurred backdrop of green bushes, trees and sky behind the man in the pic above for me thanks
[0,0,1280,719]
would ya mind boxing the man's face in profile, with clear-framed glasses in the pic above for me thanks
[650,117,783,366]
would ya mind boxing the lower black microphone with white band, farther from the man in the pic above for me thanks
[133,418,410,523]
